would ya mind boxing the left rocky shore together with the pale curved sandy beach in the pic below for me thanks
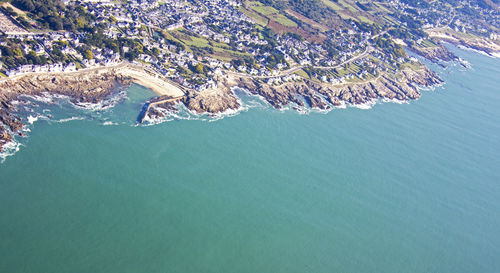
[0,62,189,152]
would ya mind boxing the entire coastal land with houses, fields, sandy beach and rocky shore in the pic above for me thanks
[0,0,500,149]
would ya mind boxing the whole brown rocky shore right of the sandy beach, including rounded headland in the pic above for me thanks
[145,67,442,120]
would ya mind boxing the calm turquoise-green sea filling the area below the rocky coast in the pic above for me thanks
[0,45,500,273]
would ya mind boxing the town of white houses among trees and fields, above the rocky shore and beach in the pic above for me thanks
[0,0,498,91]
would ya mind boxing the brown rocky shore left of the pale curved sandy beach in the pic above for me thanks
[0,73,129,151]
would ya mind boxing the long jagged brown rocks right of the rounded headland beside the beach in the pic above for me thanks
[239,68,442,110]
